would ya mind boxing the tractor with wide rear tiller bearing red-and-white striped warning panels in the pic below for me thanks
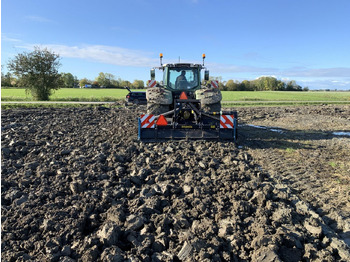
[138,54,237,141]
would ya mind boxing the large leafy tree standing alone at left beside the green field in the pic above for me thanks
[8,47,61,100]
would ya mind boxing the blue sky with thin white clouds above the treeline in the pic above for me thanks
[1,0,350,90]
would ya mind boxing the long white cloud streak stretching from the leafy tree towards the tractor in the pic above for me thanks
[22,45,159,67]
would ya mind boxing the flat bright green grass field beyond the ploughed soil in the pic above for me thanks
[1,88,350,105]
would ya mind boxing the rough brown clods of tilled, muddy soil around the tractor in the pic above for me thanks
[1,106,350,261]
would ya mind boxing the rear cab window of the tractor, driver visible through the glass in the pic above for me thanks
[168,68,198,89]
